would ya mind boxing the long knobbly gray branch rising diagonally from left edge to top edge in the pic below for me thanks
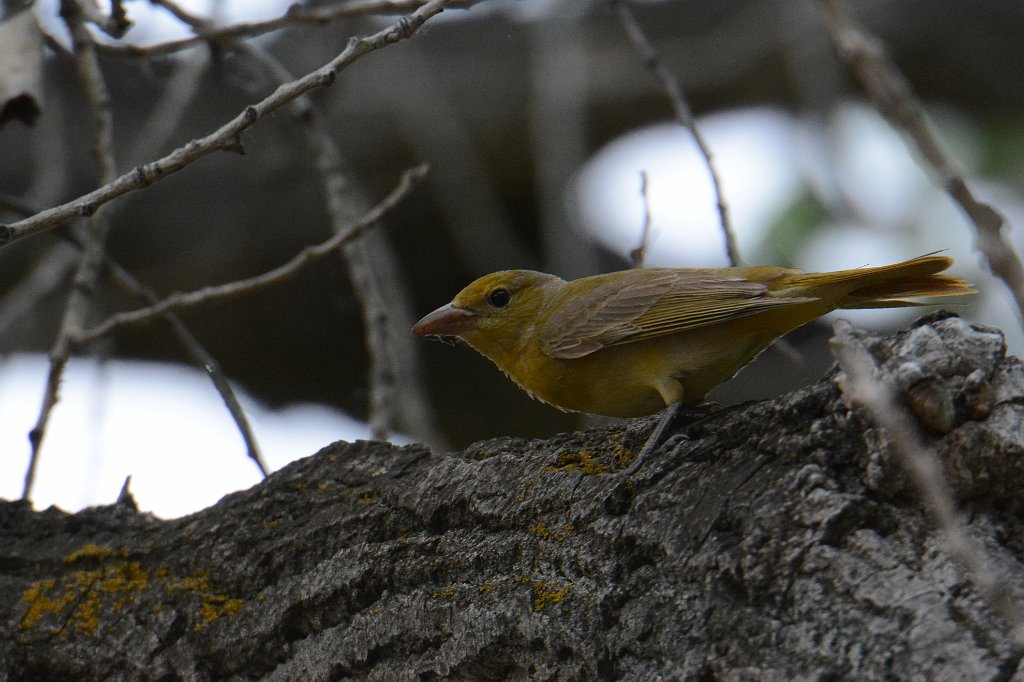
[0,0,468,246]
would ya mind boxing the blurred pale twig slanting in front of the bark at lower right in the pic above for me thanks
[833,319,1024,649]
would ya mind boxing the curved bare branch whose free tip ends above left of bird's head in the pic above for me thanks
[76,164,427,343]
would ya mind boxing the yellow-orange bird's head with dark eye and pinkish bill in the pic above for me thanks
[413,270,565,357]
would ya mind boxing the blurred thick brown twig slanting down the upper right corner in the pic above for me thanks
[818,0,1024,317]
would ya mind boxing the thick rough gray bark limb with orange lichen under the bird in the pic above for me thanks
[0,313,1024,681]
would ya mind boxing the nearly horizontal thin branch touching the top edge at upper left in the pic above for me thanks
[100,0,471,57]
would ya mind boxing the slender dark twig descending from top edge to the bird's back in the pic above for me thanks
[610,0,742,265]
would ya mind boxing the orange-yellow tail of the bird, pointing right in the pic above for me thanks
[786,254,978,308]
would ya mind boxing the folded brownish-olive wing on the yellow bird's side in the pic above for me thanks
[543,268,813,359]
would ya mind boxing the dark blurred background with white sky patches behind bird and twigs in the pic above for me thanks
[0,0,1024,516]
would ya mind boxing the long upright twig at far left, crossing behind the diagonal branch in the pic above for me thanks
[22,0,117,500]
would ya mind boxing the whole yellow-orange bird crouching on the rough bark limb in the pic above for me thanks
[413,255,975,417]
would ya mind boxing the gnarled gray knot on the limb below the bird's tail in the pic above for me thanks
[834,312,1024,501]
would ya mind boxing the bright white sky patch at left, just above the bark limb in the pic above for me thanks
[0,354,385,517]
